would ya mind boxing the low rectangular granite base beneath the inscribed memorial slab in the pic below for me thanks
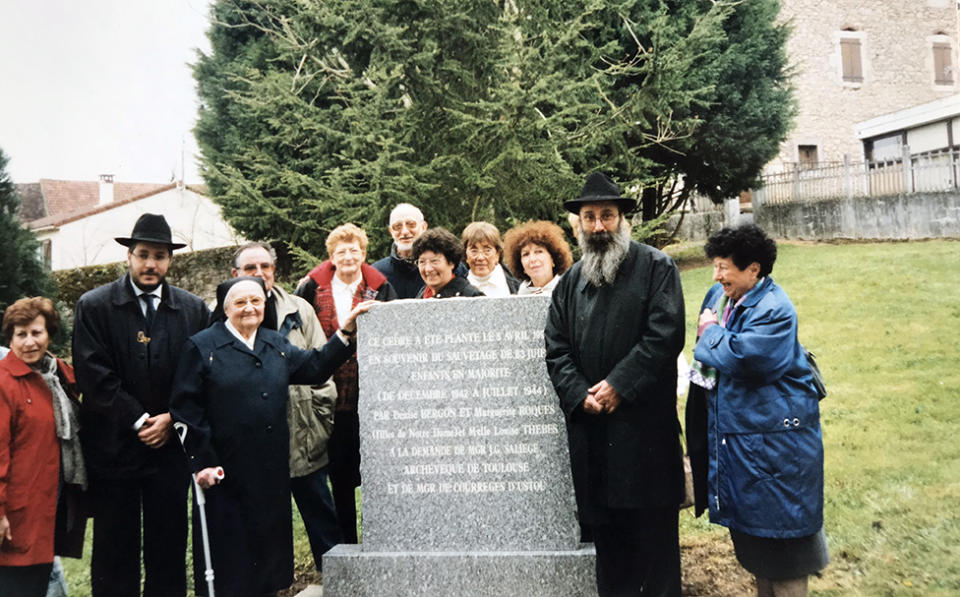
[323,544,597,597]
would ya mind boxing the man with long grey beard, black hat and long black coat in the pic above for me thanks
[544,173,684,597]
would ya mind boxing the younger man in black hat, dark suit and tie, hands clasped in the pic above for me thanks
[73,214,210,597]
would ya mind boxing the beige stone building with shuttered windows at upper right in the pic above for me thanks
[767,0,958,172]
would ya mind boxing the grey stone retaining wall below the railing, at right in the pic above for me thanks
[754,193,960,240]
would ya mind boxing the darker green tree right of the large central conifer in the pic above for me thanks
[642,0,796,219]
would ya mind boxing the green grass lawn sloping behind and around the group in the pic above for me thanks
[64,241,960,597]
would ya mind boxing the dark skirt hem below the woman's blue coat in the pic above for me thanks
[730,529,830,580]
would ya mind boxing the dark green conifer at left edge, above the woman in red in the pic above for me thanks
[0,149,53,340]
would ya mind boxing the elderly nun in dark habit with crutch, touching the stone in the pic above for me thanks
[170,276,370,597]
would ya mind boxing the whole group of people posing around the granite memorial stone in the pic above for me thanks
[0,173,827,597]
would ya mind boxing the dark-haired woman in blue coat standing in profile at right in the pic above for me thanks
[691,225,829,597]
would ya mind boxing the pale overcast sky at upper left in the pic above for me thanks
[0,0,209,183]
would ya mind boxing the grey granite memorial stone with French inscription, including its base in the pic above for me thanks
[324,296,596,597]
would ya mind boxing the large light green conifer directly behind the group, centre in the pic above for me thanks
[195,0,788,255]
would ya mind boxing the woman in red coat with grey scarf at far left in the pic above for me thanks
[0,297,86,597]
